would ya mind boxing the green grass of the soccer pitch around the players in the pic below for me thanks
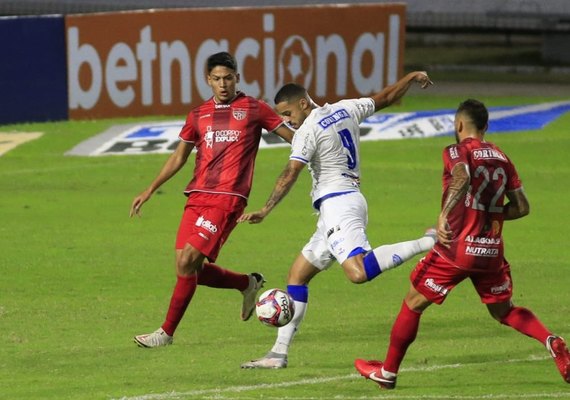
[0,92,570,399]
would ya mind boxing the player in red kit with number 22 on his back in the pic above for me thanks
[355,100,570,389]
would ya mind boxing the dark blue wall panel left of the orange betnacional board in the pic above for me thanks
[0,15,68,124]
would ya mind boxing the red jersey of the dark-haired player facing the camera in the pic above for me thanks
[179,92,283,199]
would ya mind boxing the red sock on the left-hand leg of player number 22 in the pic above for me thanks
[384,302,422,374]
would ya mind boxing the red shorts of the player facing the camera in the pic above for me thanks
[176,192,247,261]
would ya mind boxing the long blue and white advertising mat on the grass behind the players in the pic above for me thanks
[66,101,570,156]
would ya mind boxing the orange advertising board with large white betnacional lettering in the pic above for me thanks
[66,4,405,119]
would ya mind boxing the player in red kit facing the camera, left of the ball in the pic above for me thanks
[130,52,293,348]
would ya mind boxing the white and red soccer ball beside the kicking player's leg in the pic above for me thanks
[255,289,295,328]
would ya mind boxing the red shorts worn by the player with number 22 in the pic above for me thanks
[410,250,513,304]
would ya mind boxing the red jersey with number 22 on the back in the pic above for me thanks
[434,138,522,270]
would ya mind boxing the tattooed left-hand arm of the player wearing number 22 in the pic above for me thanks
[437,163,469,247]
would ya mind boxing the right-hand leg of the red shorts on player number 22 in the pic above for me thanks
[471,260,513,304]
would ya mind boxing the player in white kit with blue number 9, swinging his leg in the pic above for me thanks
[238,71,435,368]
